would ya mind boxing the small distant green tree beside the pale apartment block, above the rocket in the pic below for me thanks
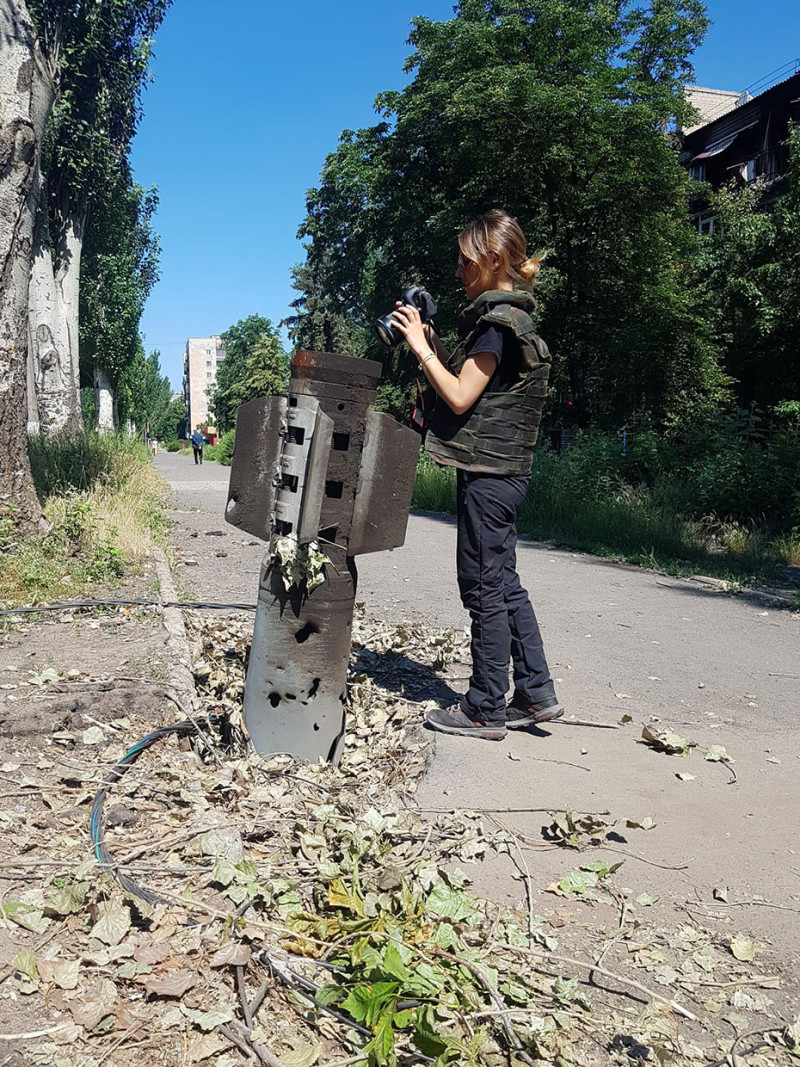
[209,315,289,433]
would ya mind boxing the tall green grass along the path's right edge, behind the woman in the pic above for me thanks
[412,432,800,582]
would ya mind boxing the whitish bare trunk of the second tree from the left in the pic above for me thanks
[28,225,82,436]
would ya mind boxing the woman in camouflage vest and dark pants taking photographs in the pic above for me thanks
[393,211,563,740]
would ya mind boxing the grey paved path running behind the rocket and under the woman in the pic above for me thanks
[157,455,800,952]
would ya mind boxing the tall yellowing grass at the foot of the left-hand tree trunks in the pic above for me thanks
[0,433,170,604]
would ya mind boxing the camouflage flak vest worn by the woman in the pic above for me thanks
[426,289,551,475]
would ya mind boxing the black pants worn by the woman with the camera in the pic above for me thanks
[455,471,555,722]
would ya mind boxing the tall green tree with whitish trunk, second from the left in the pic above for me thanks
[30,0,171,432]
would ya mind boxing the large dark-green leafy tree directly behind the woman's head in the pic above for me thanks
[292,0,724,423]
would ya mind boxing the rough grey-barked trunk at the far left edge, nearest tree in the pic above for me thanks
[0,0,53,534]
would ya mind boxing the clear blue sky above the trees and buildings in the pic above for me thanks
[132,0,800,389]
